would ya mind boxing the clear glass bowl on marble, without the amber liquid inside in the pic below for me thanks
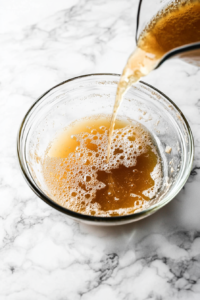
[17,74,194,225]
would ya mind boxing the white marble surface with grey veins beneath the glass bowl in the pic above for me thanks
[0,0,200,300]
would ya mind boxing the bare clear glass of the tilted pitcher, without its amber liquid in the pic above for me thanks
[135,0,200,68]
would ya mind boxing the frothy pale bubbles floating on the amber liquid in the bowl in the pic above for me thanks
[43,123,162,216]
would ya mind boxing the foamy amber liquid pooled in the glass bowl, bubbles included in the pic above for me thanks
[43,117,162,216]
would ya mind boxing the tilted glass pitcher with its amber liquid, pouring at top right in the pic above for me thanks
[135,0,200,69]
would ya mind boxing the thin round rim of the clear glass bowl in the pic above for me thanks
[17,73,194,223]
